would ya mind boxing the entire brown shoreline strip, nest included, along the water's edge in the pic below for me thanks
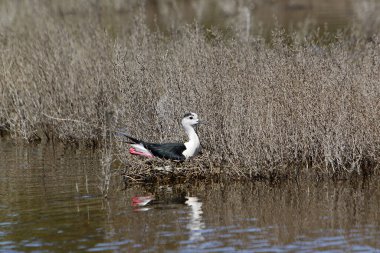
[0,132,380,187]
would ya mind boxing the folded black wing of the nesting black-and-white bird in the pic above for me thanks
[143,142,186,161]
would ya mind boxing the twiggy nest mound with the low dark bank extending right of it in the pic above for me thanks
[121,152,380,187]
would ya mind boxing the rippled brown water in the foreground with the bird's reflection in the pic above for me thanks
[0,139,380,252]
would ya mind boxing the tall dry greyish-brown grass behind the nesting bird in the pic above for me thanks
[0,0,380,182]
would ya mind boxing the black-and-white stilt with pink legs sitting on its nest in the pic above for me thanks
[121,112,200,161]
